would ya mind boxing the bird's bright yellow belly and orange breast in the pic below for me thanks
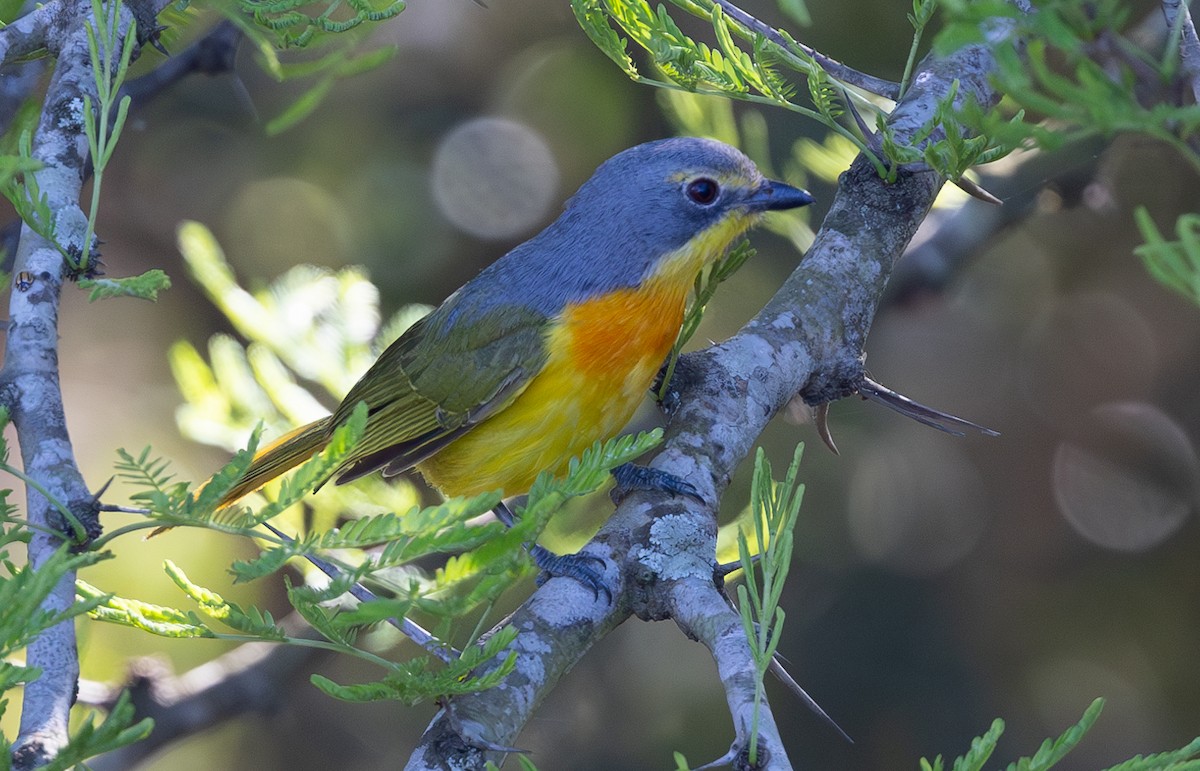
[418,286,686,496]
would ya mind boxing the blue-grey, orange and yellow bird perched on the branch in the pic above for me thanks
[221,137,814,514]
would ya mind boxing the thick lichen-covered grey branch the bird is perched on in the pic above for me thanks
[408,12,1014,769]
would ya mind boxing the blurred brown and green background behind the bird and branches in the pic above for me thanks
[2,0,1200,771]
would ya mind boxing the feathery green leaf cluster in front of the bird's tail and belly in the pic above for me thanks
[93,422,661,704]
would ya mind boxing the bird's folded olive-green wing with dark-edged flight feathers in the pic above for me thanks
[331,303,548,484]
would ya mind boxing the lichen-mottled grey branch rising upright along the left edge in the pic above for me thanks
[0,0,166,769]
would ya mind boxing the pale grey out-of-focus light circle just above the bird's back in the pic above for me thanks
[432,118,558,240]
